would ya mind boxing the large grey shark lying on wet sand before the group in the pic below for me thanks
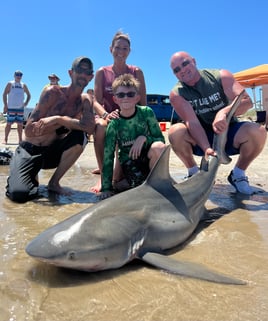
[26,93,245,285]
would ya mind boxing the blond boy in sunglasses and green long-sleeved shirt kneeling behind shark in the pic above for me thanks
[98,74,166,199]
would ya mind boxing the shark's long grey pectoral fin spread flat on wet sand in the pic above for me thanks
[140,252,246,285]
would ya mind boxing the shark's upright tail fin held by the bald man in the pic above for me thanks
[212,90,245,164]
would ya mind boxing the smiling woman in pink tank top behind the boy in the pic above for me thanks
[91,31,147,192]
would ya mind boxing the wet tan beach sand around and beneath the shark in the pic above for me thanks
[0,124,268,321]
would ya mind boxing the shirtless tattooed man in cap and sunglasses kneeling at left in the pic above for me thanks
[6,57,95,203]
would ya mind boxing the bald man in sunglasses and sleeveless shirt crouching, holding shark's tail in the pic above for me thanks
[168,51,266,195]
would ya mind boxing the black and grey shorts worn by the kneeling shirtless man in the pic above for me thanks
[6,130,87,203]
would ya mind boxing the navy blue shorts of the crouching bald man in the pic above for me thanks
[193,121,246,156]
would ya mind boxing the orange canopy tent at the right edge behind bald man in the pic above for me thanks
[234,64,268,108]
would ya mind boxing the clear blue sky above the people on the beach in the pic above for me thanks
[0,0,268,107]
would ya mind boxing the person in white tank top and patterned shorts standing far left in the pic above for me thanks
[3,70,31,145]
